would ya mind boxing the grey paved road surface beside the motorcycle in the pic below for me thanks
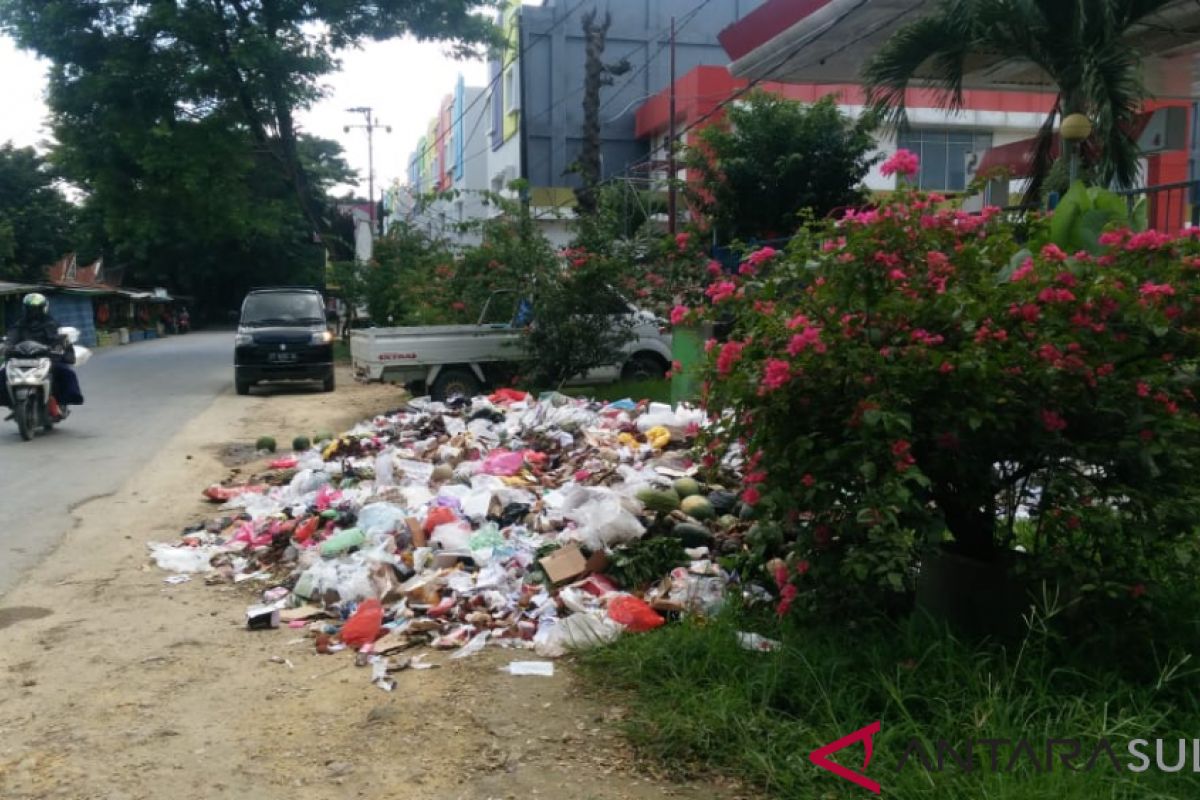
[0,332,233,595]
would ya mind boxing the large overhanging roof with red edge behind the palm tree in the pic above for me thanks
[720,0,1200,98]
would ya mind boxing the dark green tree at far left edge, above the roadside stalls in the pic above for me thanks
[0,142,76,281]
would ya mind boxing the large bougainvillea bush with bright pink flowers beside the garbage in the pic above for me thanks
[706,151,1200,610]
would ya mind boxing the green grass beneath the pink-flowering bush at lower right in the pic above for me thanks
[582,599,1200,800]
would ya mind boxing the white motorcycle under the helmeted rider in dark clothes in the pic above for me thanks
[2,327,91,441]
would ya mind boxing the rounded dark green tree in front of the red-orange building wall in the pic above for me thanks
[686,92,875,242]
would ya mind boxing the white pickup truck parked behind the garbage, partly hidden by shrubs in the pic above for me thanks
[350,291,671,399]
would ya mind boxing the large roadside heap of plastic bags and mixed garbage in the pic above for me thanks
[150,390,762,688]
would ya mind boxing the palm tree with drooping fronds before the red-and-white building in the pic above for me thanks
[863,0,1177,199]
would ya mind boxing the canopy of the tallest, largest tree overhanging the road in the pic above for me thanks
[0,0,492,311]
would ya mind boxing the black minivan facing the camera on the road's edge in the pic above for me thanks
[233,288,334,395]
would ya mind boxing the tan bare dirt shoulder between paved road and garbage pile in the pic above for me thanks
[0,375,739,800]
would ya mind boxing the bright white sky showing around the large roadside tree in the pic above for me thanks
[0,36,487,197]
